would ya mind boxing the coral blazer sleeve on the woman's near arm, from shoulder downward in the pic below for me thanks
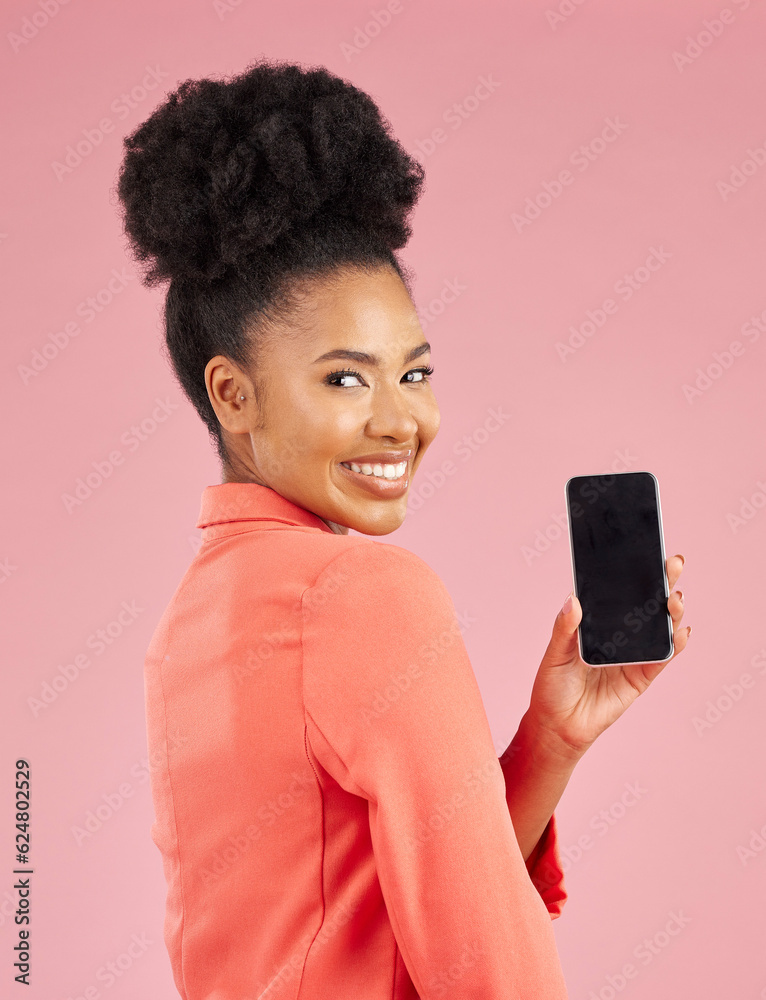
[302,540,567,1000]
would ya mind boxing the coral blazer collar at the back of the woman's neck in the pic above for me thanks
[195,483,334,534]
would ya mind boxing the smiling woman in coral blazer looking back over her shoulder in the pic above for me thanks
[119,61,687,1000]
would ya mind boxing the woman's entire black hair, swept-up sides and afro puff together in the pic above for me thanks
[117,59,424,464]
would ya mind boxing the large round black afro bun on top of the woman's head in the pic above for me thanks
[117,60,424,285]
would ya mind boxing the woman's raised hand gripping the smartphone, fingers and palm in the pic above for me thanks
[526,556,691,760]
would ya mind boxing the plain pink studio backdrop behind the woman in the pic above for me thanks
[0,0,766,1000]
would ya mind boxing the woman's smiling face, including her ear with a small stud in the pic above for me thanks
[205,267,440,535]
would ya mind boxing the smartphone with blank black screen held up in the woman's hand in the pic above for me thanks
[564,472,673,667]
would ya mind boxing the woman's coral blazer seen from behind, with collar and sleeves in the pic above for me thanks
[144,483,567,1000]
